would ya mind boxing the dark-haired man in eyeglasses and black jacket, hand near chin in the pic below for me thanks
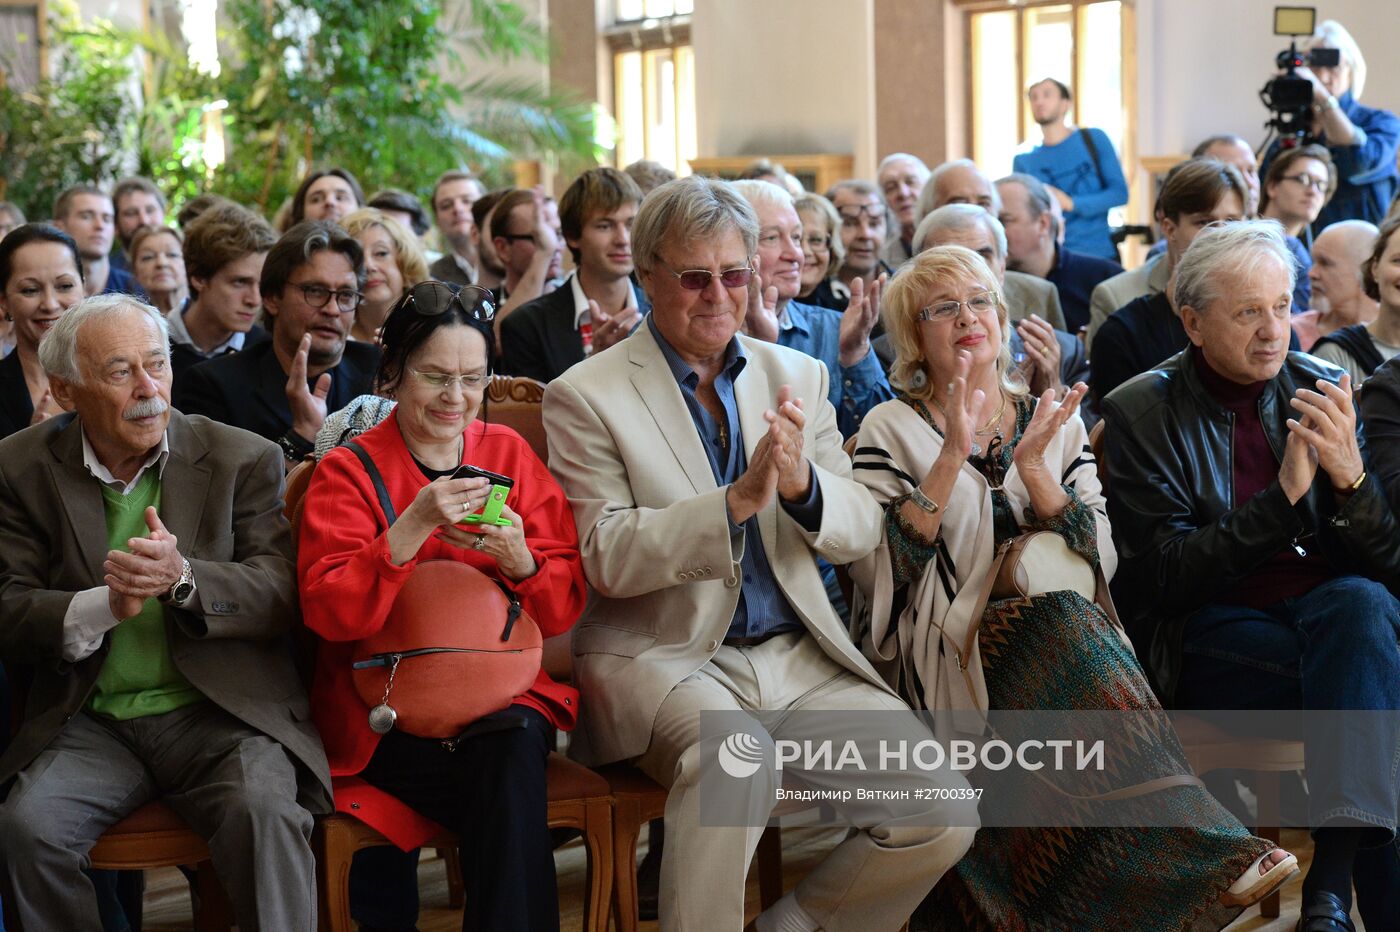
[175,220,379,465]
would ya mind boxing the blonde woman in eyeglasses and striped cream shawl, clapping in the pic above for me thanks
[853,246,1296,931]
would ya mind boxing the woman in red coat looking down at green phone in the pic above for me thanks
[297,283,585,932]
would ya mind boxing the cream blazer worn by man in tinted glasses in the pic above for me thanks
[545,326,890,764]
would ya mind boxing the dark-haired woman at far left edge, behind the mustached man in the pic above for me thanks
[0,224,83,438]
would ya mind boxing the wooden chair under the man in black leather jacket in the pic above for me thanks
[1089,421,1306,919]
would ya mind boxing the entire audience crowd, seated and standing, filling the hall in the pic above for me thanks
[0,12,1400,932]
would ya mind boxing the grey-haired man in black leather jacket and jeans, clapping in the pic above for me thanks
[1103,221,1400,932]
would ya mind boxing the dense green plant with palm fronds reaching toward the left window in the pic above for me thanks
[216,0,599,211]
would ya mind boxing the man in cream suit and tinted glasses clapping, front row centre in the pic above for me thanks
[545,178,974,932]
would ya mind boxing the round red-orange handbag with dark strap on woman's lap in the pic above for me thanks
[346,441,543,737]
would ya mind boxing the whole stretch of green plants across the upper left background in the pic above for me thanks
[0,0,602,216]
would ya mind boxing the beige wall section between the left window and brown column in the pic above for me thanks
[690,0,879,175]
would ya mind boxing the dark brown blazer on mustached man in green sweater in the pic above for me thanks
[0,411,330,812]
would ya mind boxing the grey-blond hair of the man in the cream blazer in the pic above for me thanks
[631,175,759,271]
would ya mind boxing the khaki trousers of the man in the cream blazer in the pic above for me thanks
[636,631,976,932]
